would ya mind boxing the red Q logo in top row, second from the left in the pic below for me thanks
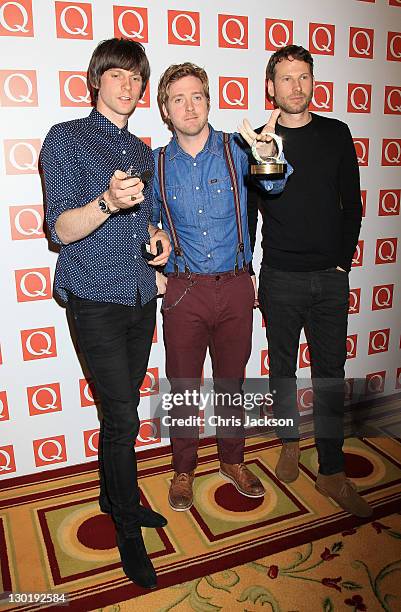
[55,2,93,40]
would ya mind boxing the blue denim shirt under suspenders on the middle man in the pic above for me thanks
[152,126,292,274]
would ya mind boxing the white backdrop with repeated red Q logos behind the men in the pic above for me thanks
[0,0,401,478]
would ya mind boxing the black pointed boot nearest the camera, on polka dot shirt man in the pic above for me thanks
[116,528,157,589]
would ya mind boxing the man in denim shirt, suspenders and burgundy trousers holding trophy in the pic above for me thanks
[153,63,286,510]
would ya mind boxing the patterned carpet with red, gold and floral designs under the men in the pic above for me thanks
[0,430,401,612]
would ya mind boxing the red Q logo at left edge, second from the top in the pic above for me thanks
[0,70,38,107]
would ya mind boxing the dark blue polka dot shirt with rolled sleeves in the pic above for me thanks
[41,109,157,306]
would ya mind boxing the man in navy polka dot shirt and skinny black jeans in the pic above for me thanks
[41,38,171,588]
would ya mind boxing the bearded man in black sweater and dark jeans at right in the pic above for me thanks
[248,45,372,516]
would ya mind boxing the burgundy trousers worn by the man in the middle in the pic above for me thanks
[162,270,254,473]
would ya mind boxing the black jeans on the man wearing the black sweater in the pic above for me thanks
[259,265,349,475]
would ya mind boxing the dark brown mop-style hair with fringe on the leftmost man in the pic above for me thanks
[88,38,150,105]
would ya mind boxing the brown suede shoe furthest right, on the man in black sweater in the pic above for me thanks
[315,472,373,518]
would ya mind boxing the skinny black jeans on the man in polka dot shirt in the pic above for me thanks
[67,294,156,537]
